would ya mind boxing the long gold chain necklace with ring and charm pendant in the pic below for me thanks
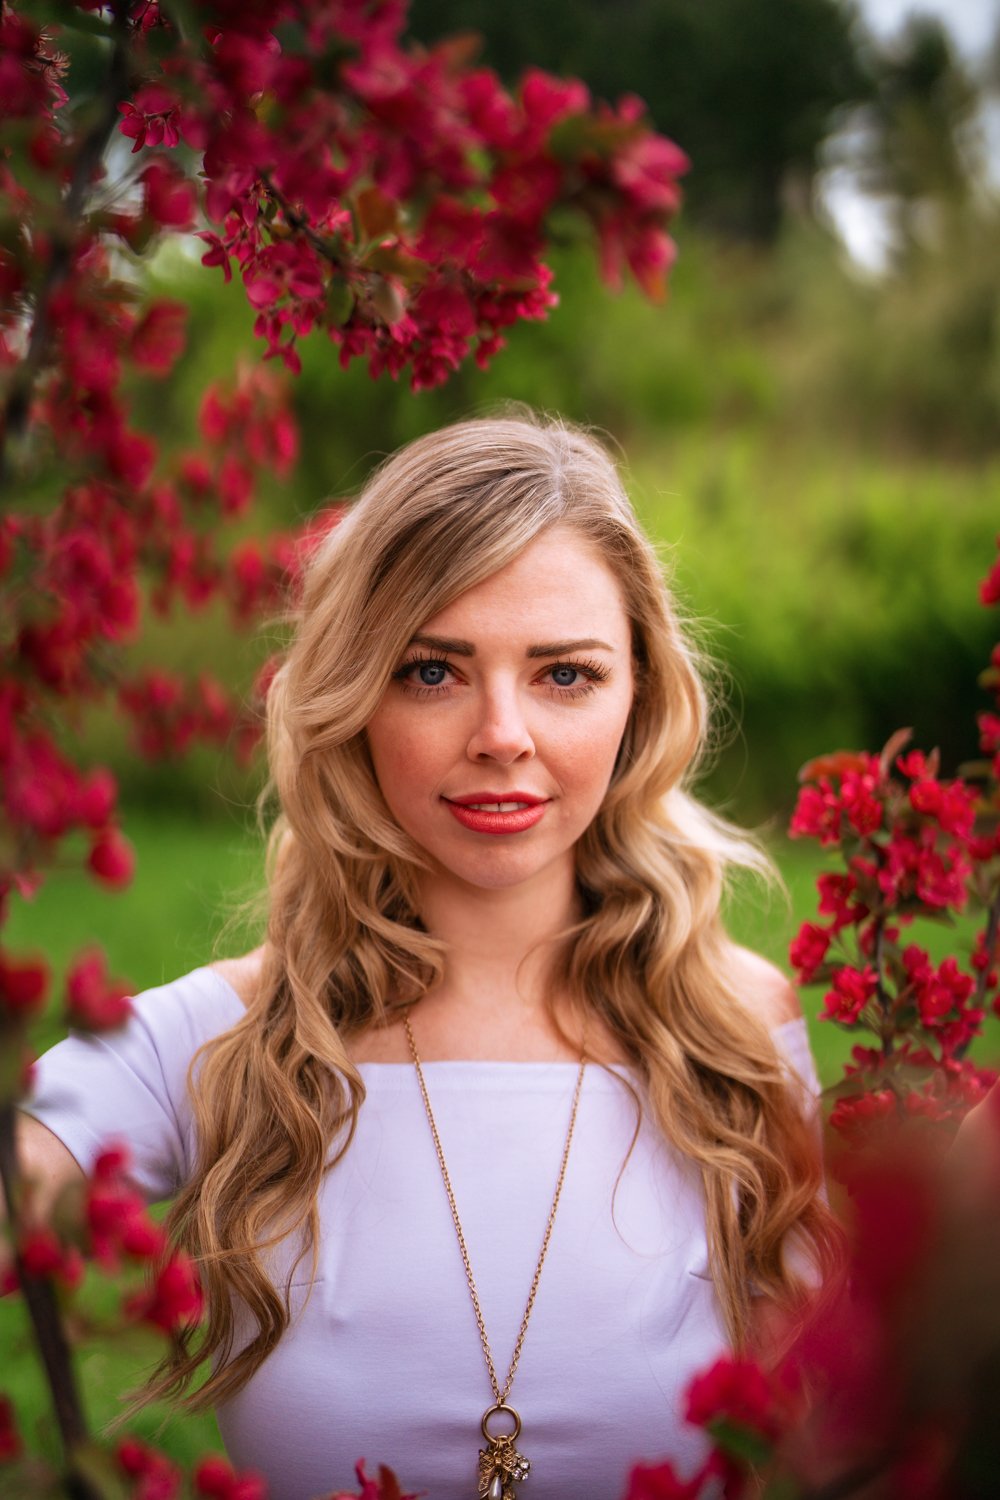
[403,1016,586,1500]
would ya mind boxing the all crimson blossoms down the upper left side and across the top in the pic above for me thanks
[0,0,687,1044]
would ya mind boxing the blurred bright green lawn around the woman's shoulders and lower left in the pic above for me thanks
[0,809,1000,1464]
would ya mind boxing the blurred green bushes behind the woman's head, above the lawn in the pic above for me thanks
[103,210,1000,821]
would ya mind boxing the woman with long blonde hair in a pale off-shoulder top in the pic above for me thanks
[19,417,834,1500]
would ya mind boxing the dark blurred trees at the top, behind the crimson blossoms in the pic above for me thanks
[411,0,871,243]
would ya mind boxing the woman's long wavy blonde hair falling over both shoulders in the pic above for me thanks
[147,414,835,1409]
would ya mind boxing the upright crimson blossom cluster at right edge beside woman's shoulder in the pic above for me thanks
[790,540,1000,1145]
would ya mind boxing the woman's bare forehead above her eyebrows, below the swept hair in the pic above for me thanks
[423,527,630,645]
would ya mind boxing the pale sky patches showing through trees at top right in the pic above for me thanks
[820,0,1000,272]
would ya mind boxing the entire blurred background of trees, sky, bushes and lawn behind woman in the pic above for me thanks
[9,0,1000,1077]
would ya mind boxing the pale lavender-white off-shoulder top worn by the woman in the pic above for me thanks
[24,969,816,1500]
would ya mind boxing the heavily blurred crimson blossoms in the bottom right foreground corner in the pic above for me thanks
[624,1089,1000,1500]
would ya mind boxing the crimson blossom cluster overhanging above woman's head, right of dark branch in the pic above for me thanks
[105,0,687,390]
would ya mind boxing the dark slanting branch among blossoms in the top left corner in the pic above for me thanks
[0,6,129,489]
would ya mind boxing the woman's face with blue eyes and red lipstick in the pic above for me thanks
[367,527,633,893]
